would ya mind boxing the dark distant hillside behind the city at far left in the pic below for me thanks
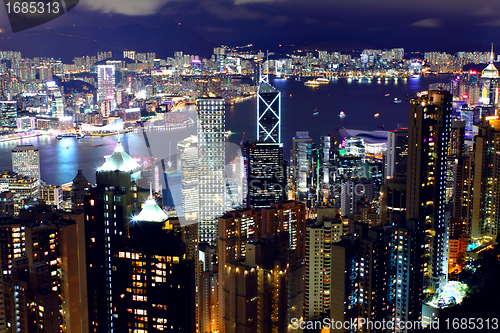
[0,24,217,63]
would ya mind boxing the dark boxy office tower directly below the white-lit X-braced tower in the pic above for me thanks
[244,141,285,208]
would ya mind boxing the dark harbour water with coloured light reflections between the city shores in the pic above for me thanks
[0,76,451,185]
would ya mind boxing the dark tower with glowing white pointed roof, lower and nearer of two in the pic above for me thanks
[110,196,196,333]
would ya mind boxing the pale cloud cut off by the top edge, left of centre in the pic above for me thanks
[80,0,171,16]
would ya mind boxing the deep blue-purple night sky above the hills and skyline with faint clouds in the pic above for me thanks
[0,0,500,53]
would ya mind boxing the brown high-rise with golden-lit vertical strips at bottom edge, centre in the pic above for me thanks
[221,232,304,333]
